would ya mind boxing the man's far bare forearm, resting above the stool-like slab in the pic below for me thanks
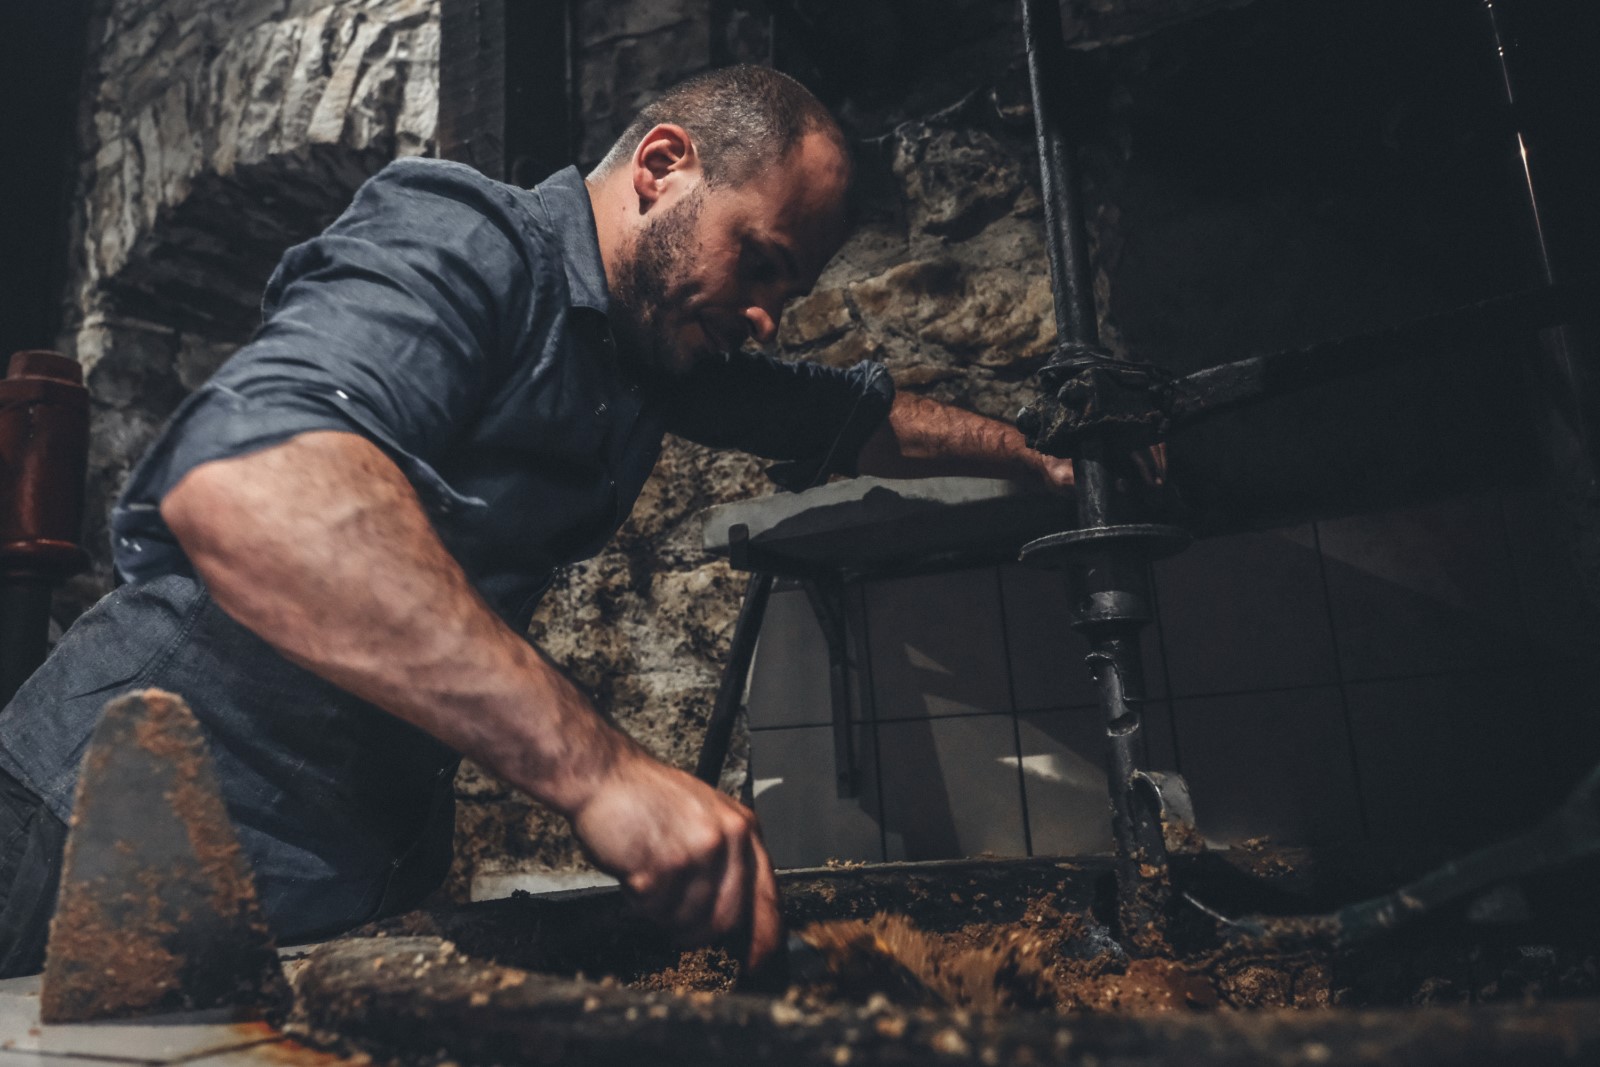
[858,394,1072,488]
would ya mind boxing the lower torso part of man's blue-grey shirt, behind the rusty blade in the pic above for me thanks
[0,574,458,939]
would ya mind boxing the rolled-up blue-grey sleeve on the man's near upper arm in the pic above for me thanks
[112,160,540,581]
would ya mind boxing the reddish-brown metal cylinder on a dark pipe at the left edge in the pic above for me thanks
[0,350,90,704]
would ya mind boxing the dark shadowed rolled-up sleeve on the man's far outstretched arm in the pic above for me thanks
[666,354,894,491]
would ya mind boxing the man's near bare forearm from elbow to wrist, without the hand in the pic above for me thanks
[162,434,630,814]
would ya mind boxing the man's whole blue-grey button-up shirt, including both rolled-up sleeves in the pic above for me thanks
[0,160,893,937]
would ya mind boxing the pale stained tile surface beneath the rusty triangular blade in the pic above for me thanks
[0,974,346,1067]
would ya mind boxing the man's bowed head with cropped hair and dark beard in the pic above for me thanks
[589,67,850,371]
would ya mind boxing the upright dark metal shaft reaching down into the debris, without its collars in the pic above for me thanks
[1022,0,1170,949]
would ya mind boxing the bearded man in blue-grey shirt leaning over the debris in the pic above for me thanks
[0,67,1070,974]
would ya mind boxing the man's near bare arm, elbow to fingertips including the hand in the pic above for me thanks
[162,432,782,966]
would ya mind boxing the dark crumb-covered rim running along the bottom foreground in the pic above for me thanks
[301,937,1600,1067]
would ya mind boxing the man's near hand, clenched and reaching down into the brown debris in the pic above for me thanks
[571,744,782,971]
